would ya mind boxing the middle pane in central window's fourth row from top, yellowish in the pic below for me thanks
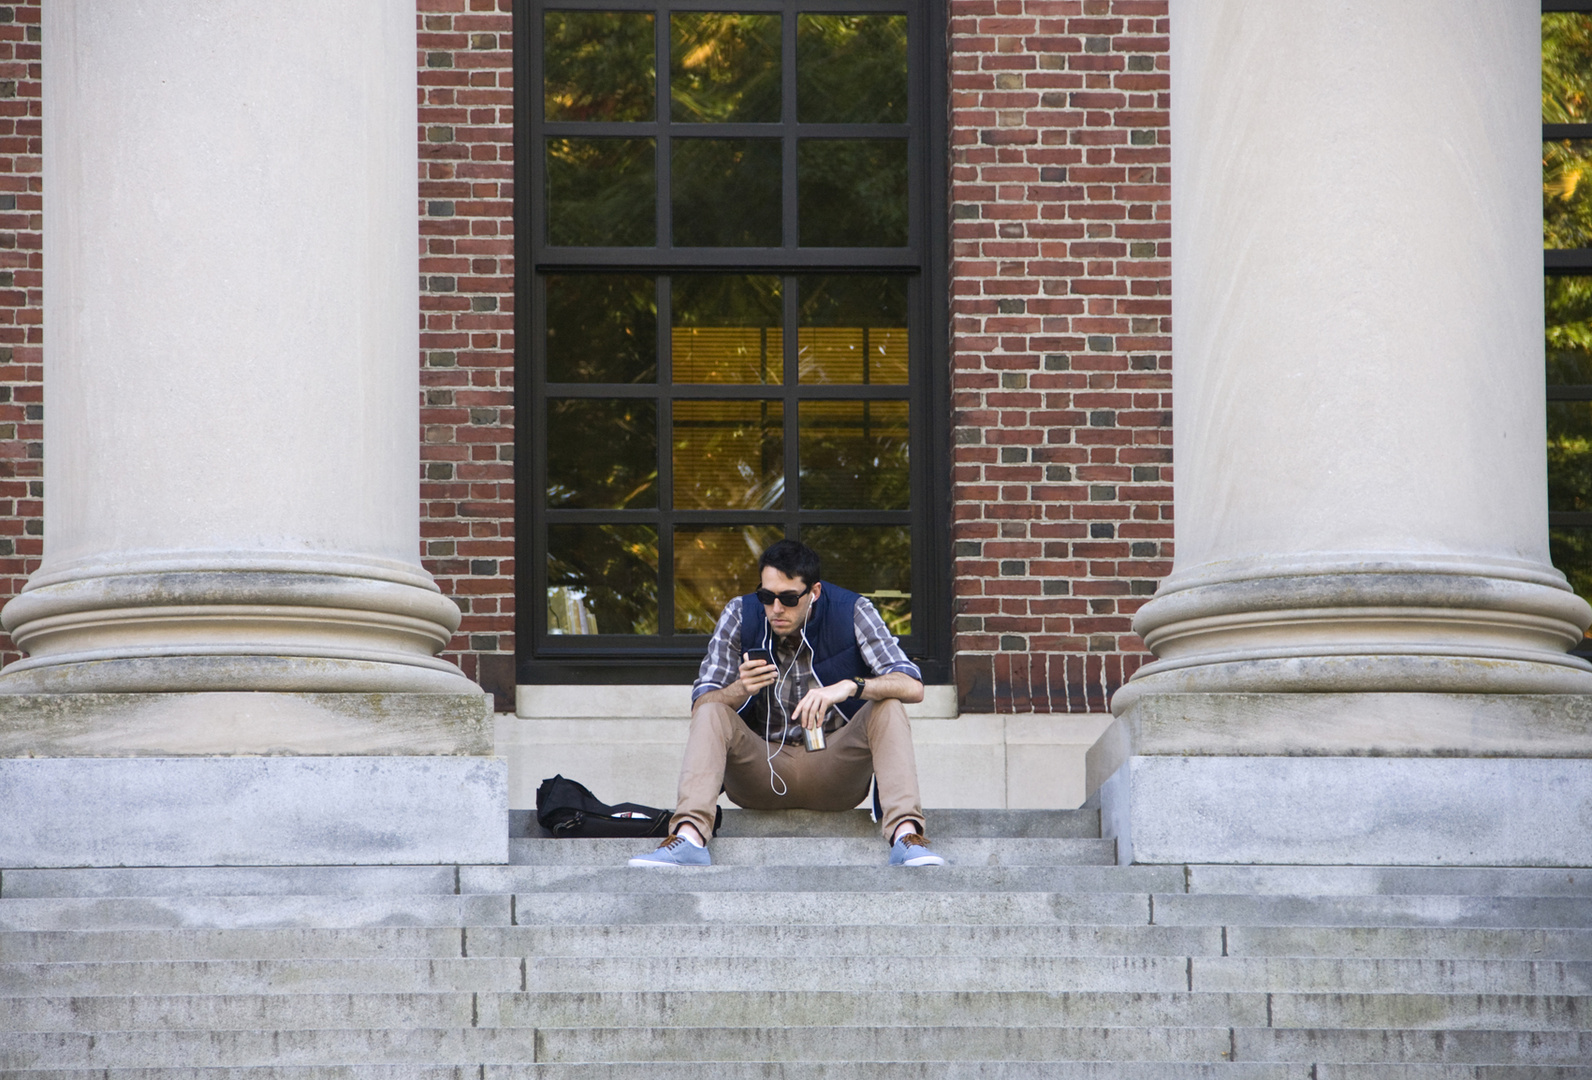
[673,401,785,510]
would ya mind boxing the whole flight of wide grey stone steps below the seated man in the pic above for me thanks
[0,811,1592,1080]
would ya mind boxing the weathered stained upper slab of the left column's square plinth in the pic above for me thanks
[0,691,492,758]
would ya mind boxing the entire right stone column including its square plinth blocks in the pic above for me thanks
[1103,0,1592,865]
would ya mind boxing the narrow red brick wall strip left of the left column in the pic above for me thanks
[0,0,45,663]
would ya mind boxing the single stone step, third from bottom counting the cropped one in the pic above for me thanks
[0,989,1592,1032]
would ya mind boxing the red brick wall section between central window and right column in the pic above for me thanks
[950,0,1172,712]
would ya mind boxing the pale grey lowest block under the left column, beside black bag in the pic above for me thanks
[0,757,508,867]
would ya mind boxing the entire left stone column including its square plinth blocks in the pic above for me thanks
[0,0,508,867]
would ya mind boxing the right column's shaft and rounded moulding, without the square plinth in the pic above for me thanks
[1127,0,1592,699]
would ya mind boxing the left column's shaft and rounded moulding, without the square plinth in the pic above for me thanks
[0,0,474,693]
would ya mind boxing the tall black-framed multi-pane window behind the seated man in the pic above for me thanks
[516,0,950,683]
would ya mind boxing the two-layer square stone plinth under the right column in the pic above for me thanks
[1092,693,1592,867]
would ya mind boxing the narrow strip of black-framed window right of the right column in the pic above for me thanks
[1543,0,1592,652]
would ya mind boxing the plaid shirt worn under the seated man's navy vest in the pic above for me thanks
[691,596,923,742]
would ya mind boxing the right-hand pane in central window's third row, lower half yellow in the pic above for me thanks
[796,274,907,384]
